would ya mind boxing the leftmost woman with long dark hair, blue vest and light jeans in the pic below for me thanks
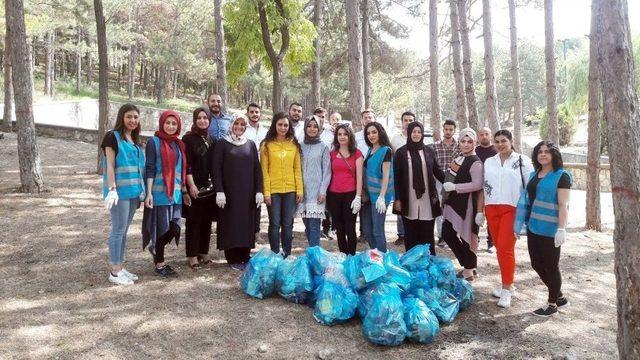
[101,104,144,285]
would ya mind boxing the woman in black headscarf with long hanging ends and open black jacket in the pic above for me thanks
[393,121,444,256]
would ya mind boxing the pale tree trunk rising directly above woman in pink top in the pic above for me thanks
[345,0,364,130]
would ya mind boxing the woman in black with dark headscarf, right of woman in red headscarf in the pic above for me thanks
[182,106,216,270]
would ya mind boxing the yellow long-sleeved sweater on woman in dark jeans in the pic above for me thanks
[260,140,304,197]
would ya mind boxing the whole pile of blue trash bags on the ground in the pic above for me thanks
[240,245,474,346]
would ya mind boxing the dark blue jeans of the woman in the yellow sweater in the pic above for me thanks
[267,192,296,257]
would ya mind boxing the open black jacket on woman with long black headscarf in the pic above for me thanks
[393,145,444,218]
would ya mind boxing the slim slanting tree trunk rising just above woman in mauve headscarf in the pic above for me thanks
[457,0,480,130]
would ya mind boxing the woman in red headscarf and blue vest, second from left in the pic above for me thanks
[142,110,191,278]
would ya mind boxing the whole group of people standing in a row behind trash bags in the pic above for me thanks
[102,94,572,316]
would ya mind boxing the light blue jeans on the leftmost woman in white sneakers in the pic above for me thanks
[109,198,140,265]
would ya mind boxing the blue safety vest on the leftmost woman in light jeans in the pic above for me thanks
[102,130,145,200]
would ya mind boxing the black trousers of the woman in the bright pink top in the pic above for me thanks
[327,191,358,255]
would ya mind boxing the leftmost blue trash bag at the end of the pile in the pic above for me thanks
[240,248,282,299]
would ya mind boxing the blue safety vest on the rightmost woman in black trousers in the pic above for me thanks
[514,169,571,237]
